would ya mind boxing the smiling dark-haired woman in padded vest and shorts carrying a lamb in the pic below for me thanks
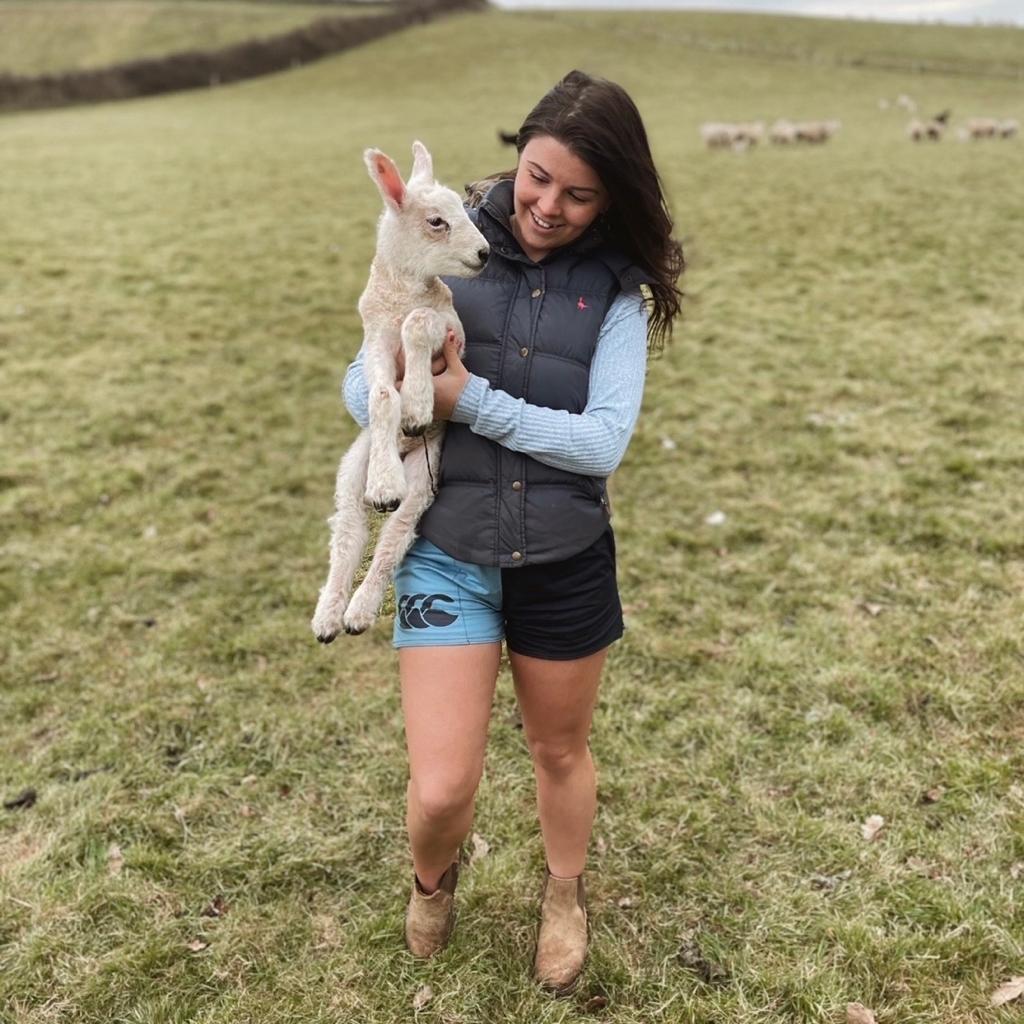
[345,71,683,992]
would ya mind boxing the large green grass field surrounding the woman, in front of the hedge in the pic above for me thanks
[0,13,1024,1024]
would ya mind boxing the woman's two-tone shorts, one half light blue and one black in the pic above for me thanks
[394,526,623,660]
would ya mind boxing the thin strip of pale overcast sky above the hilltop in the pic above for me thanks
[493,0,1024,26]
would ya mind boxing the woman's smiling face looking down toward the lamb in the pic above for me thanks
[512,135,609,262]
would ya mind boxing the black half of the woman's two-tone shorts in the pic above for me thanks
[502,526,623,662]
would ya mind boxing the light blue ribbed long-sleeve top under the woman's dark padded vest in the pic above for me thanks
[342,292,647,477]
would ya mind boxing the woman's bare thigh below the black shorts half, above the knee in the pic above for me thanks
[509,647,608,763]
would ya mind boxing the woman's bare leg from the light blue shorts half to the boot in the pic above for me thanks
[398,643,501,893]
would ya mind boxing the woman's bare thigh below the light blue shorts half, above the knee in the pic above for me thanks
[398,643,501,792]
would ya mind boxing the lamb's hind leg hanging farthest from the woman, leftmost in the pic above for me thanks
[311,430,370,643]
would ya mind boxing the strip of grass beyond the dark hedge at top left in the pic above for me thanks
[0,0,381,75]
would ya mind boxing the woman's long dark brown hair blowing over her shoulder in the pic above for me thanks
[515,71,685,349]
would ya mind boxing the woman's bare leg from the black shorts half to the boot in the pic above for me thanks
[509,648,607,879]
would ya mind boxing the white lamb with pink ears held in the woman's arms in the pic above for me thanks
[311,142,489,643]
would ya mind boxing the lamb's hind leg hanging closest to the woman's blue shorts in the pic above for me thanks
[345,431,443,633]
